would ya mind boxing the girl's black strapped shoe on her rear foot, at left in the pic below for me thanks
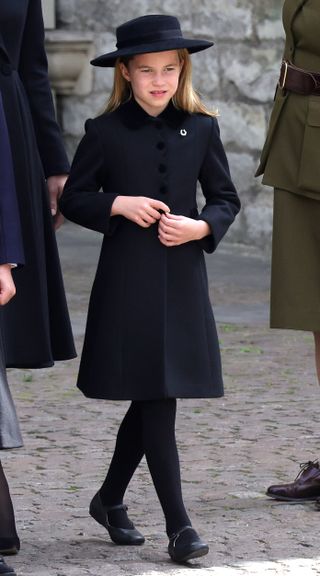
[89,492,144,546]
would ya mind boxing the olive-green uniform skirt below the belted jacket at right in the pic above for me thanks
[270,189,320,332]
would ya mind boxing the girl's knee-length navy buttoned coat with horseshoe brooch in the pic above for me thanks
[60,100,240,400]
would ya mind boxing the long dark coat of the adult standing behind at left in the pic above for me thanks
[0,0,75,368]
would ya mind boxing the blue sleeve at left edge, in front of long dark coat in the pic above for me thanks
[0,94,24,264]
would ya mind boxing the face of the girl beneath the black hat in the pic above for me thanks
[120,50,182,116]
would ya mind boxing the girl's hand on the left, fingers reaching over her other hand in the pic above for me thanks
[111,196,170,228]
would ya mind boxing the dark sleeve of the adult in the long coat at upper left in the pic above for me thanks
[19,0,69,178]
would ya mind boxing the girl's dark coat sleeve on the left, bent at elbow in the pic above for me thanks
[59,120,121,235]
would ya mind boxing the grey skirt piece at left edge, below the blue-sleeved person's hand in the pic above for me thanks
[0,330,22,450]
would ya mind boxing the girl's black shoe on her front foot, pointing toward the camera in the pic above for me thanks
[168,526,209,563]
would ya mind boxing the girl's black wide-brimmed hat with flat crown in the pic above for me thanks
[91,14,213,66]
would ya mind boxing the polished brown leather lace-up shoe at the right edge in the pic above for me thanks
[267,460,320,502]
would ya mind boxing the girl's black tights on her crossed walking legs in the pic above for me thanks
[100,399,190,535]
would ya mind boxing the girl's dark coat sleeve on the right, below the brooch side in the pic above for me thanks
[199,118,240,253]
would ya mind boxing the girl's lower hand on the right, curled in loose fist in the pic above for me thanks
[159,214,211,246]
